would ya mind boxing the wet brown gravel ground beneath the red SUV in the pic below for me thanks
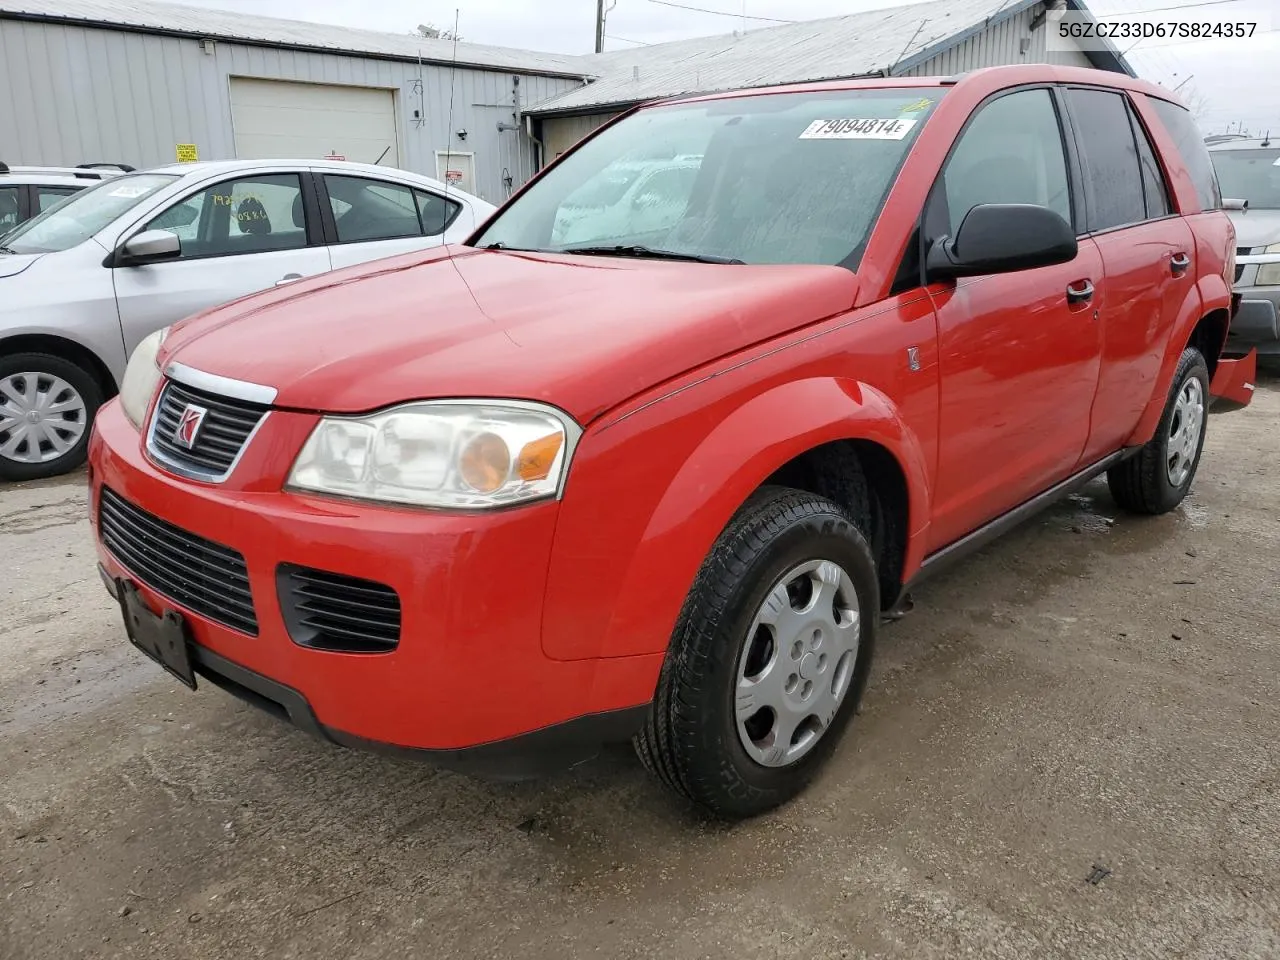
[0,375,1280,960]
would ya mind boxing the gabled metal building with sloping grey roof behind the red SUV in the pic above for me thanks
[529,0,1134,161]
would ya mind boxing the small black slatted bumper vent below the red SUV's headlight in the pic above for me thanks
[276,564,401,653]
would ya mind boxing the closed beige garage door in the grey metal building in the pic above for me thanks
[232,77,399,166]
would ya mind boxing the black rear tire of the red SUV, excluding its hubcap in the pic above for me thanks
[1107,347,1208,515]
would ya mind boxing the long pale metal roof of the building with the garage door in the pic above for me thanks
[0,0,588,78]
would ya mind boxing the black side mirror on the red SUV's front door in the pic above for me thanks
[925,204,1078,282]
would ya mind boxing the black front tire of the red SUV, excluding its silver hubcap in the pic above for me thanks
[635,486,879,819]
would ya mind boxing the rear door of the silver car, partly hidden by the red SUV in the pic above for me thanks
[316,173,465,269]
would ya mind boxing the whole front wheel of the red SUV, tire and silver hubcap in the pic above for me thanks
[636,488,879,819]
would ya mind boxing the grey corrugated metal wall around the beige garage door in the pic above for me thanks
[0,19,580,202]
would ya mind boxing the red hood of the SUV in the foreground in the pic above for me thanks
[161,248,858,422]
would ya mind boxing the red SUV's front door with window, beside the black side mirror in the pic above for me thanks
[924,87,1102,549]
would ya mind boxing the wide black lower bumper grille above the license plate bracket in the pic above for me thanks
[97,486,257,636]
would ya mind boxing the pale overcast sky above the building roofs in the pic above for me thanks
[172,0,1280,132]
